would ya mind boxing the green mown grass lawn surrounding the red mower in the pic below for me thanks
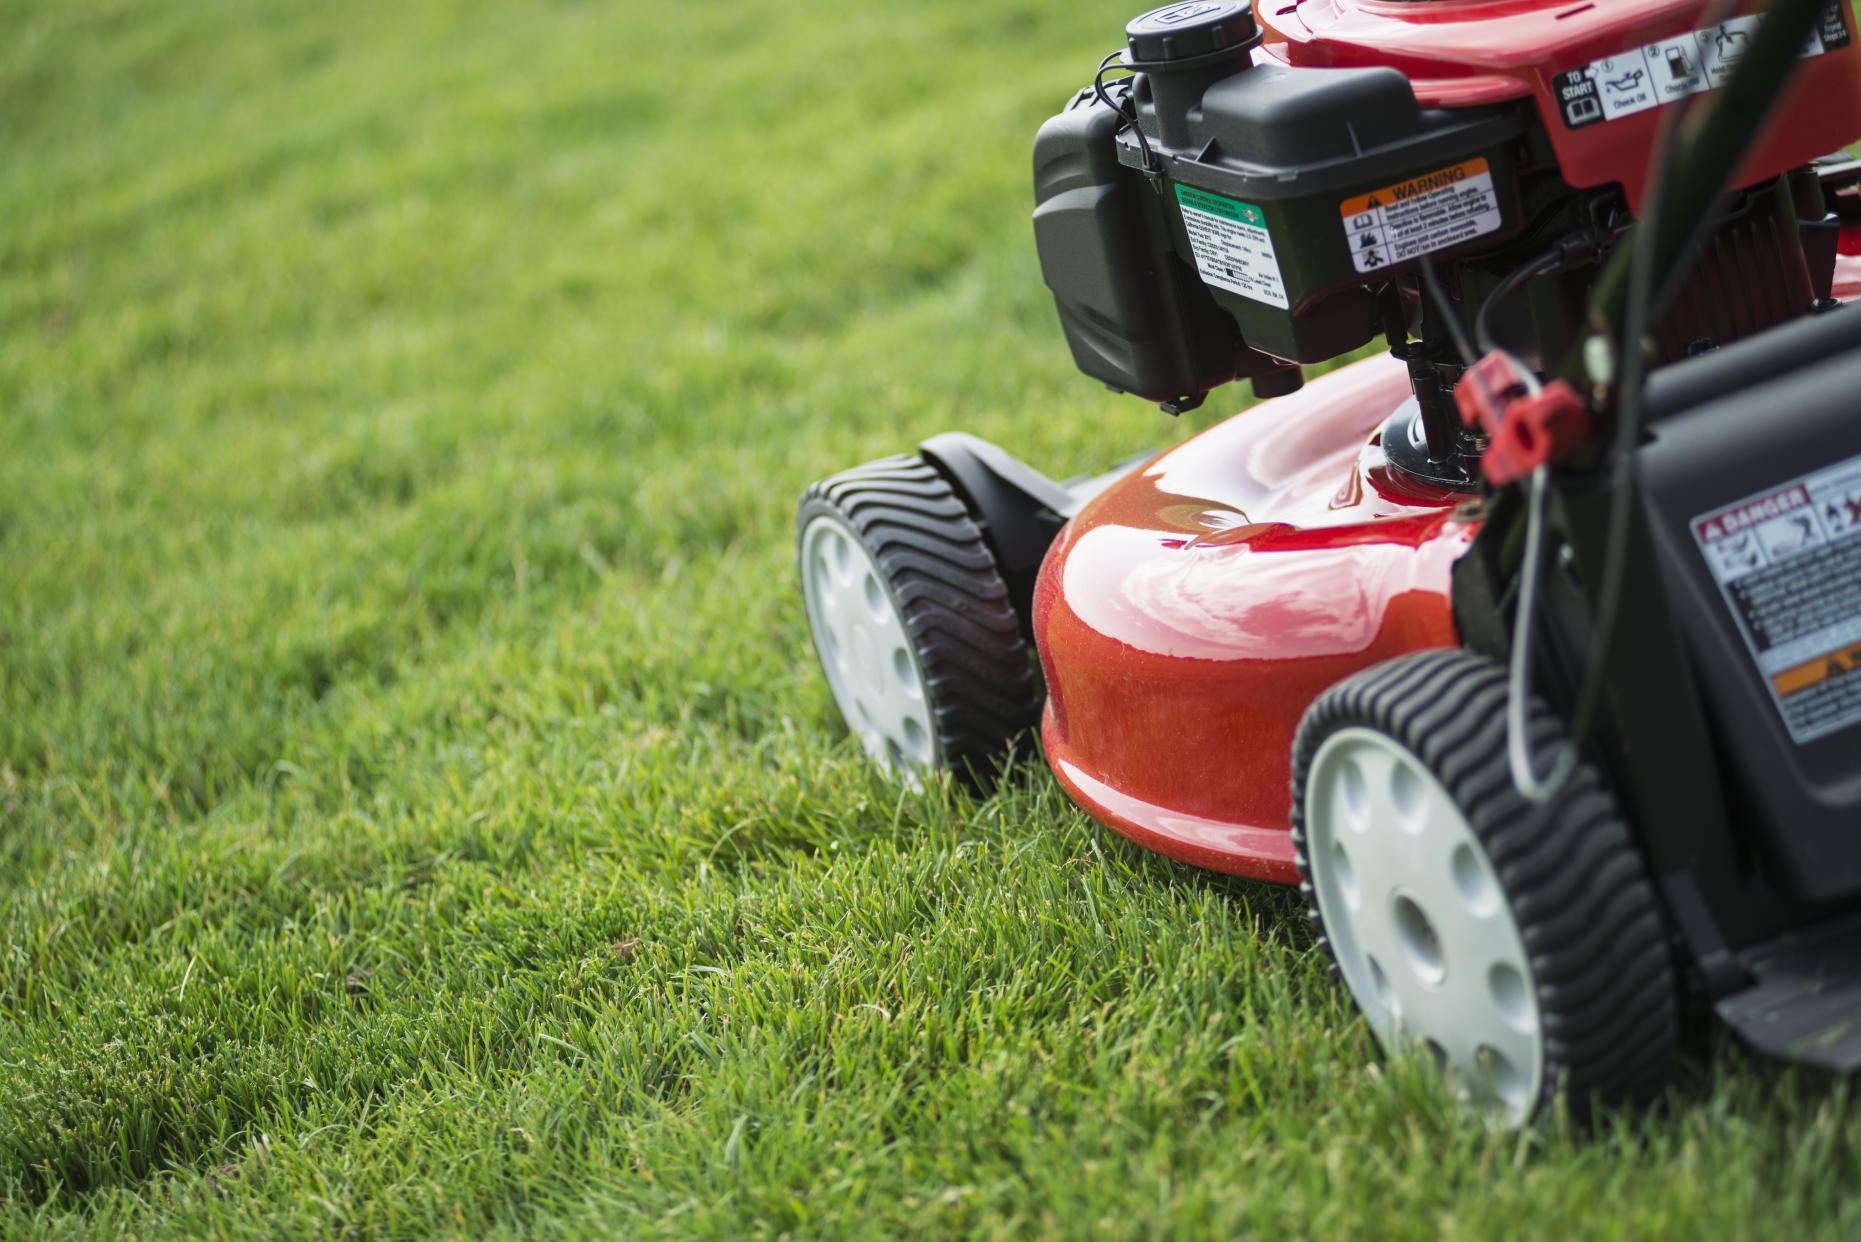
[0,0,1861,1242]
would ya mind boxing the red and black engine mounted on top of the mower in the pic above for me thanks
[1035,0,1861,488]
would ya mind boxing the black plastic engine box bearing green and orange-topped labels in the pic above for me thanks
[1118,63,1526,363]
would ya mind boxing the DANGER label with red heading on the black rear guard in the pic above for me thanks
[1694,458,1861,745]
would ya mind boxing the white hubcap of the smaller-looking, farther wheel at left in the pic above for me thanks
[802,516,938,776]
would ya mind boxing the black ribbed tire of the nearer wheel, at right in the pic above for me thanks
[1292,650,1679,1123]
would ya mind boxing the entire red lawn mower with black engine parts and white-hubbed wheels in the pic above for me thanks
[798,0,1861,1125]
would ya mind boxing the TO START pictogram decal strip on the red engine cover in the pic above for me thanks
[1550,0,1852,128]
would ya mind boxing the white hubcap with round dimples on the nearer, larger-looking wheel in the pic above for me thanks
[1305,726,1545,1127]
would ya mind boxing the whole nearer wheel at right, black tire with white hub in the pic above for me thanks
[1293,650,1679,1127]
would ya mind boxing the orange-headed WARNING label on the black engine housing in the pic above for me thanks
[1338,160,1500,272]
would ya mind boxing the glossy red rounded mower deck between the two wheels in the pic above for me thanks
[1033,356,1478,883]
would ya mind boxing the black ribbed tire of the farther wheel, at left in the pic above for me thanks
[795,454,1040,786]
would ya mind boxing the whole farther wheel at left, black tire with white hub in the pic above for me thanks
[795,456,1040,784]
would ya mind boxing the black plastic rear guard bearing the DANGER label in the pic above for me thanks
[1640,320,1861,901]
